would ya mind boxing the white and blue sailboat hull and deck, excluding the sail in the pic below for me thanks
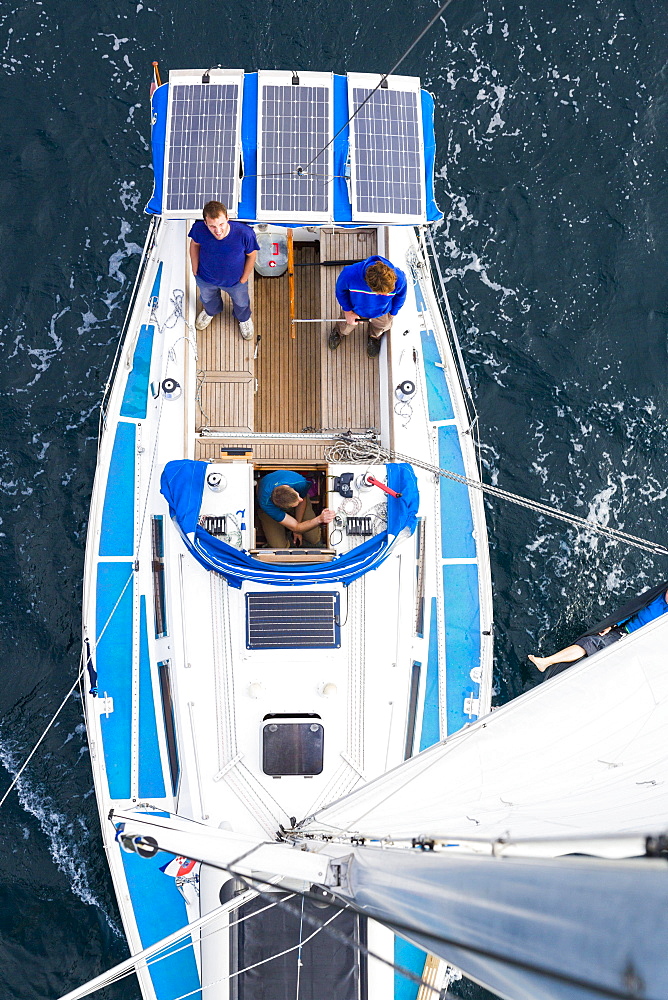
[77,62,492,1000]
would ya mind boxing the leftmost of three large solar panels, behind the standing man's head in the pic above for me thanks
[164,82,240,215]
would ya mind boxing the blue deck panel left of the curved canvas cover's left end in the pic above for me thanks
[100,423,136,556]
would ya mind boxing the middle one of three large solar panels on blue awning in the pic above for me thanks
[258,84,331,217]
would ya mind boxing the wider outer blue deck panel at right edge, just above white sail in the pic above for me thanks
[443,563,480,735]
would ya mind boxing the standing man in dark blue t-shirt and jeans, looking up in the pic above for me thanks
[188,201,260,340]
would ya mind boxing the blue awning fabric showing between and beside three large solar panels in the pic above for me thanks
[146,73,443,227]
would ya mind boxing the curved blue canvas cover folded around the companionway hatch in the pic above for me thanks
[160,459,420,587]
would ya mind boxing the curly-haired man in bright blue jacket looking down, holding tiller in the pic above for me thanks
[328,256,406,358]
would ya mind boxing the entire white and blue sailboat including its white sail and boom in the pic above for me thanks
[73,62,668,1000]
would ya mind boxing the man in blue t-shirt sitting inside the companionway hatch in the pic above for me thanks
[257,469,335,549]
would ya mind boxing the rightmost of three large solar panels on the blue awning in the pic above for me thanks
[351,87,424,218]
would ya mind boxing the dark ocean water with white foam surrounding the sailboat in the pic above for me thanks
[0,0,668,1000]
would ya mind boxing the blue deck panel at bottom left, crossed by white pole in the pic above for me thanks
[121,851,202,1000]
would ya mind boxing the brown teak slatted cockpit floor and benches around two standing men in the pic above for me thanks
[196,230,380,464]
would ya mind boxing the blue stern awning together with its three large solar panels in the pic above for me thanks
[146,69,442,226]
